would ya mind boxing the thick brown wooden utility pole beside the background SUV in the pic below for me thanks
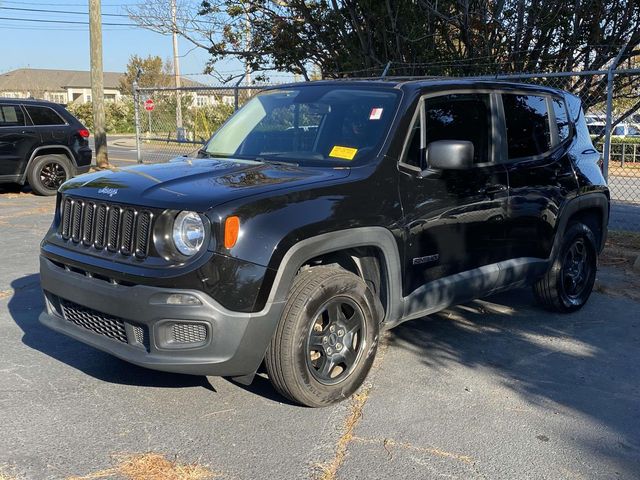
[89,0,109,168]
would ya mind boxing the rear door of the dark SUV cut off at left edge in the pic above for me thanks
[0,103,40,179]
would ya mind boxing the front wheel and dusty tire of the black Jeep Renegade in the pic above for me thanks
[265,266,381,407]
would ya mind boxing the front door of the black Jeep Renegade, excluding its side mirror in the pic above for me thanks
[399,91,508,296]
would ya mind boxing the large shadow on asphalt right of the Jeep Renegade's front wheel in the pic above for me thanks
[388,289,640,473]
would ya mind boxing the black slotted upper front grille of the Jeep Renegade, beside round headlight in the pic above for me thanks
[60,198,153,258]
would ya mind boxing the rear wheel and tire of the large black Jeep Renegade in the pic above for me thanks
[533,222,598,313]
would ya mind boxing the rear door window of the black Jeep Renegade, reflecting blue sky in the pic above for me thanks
[502,94,551,159]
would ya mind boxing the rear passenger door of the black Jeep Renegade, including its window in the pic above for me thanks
[501,91,577,259]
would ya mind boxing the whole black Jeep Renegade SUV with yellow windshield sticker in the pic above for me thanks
[40,81,609,406]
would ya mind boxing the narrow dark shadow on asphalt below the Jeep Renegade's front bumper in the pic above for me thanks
[9,274,216,392]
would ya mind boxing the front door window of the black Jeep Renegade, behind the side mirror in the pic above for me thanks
[425,93,491,163]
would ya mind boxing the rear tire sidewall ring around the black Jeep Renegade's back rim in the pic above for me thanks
[554,223,598,312]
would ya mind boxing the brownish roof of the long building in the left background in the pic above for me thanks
[0,68,202,92]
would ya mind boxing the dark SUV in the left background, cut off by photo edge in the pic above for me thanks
[0,98,91,195]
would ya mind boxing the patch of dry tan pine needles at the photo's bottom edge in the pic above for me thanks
[69,452,221,480]
